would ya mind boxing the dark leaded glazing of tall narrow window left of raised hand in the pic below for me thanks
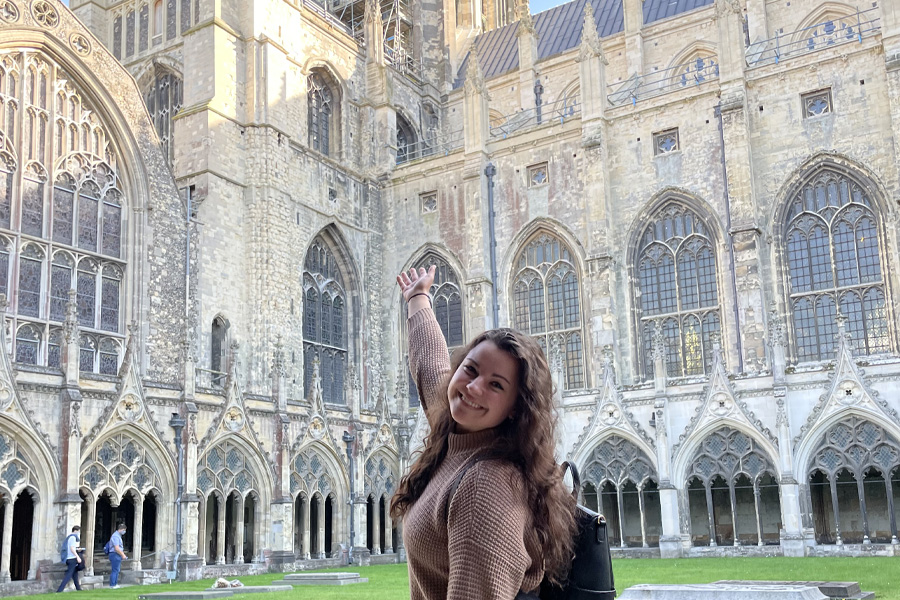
[303,236,347,404]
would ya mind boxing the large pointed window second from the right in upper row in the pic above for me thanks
[636,202,721,379]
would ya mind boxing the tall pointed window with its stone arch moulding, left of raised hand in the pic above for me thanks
[301,225,361,404]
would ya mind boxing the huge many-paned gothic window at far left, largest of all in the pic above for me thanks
[0,52,126,375]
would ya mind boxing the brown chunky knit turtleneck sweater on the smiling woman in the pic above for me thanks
[403,309,544,600]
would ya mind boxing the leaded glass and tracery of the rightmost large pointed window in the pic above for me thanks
[785,169,890,362]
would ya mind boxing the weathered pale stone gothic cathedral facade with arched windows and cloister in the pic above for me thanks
[0,0,900,593]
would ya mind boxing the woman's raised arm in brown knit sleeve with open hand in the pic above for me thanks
[397,266,450,411]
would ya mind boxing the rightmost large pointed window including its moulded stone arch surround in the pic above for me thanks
[772,153,896,362]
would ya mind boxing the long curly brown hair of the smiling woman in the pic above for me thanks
[391,329,575,583]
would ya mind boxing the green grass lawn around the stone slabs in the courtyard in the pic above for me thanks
[38,558,900,600]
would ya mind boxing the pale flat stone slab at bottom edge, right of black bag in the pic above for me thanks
[619,582,828,600]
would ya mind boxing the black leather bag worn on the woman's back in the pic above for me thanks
[540,461,616,600]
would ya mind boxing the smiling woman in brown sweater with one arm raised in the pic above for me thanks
[391,267,576,600]
